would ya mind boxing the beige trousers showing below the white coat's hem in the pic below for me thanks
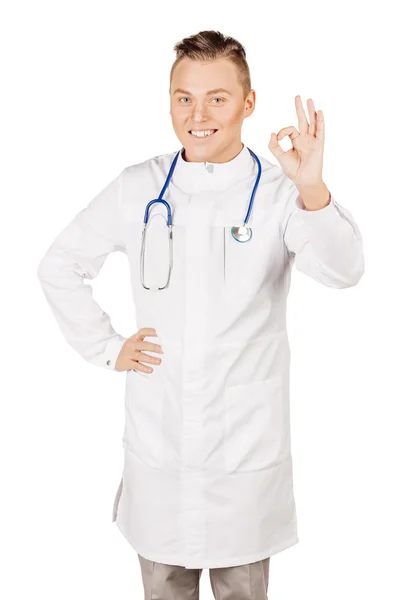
[138,554,270,600]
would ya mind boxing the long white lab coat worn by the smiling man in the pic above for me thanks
[38,145,364,568]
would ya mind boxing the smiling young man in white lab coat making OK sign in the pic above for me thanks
[38,31,364,600]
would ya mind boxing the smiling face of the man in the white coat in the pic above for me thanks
[170,58,255,163]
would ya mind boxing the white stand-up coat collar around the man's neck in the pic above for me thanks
[171,144,257,193]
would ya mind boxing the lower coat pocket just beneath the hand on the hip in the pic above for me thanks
[123,370,165,469]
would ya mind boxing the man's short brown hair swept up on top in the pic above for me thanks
[169,30,251,98]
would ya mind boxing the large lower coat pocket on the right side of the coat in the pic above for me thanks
[224,375,287,472]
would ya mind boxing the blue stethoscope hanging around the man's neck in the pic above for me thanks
[140,147,262,291]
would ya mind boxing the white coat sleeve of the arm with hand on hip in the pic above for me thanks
[37,171,127,370]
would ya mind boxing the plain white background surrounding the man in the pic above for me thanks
[0,0,400,600]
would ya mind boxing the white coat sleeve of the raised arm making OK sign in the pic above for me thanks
[283,178,365,288]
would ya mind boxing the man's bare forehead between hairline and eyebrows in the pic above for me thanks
[171,58,240,93]
